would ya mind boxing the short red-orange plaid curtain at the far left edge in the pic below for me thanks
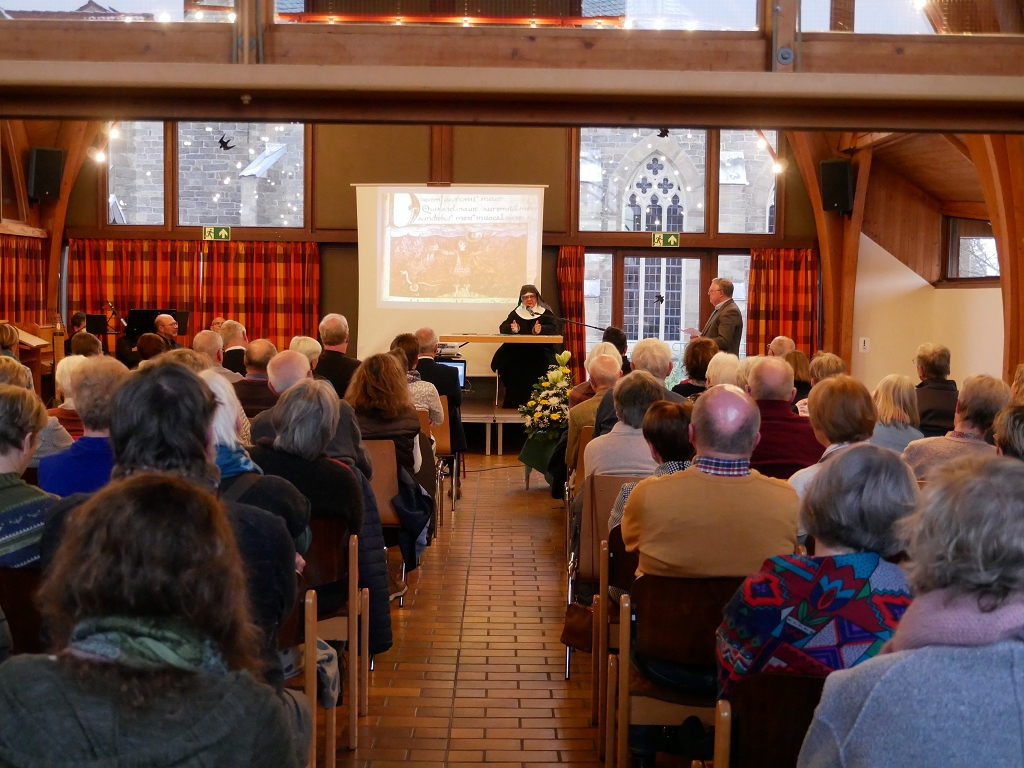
[0,234,49,325]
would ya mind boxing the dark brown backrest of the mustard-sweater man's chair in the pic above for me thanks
[630,574,743,667]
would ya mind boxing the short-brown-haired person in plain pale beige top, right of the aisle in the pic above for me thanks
[578,372,665,482]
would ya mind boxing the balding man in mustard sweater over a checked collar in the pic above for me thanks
[622,385,800,578]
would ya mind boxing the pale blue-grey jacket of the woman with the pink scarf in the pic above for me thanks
[797,641,1024,768]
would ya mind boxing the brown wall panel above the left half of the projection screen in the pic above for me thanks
[313,124,430,230]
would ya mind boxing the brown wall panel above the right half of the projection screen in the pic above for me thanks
[452,126,569,232]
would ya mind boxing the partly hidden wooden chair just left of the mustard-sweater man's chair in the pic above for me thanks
[591,525,640,757]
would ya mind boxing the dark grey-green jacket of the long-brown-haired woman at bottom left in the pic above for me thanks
[0,655,297,768]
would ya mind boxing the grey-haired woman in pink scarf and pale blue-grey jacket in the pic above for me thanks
[798,456,1024,768]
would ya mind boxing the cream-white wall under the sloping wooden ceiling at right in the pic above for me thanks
[851,234,1002,389]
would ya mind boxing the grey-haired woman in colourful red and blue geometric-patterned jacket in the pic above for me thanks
[716,443,918,698]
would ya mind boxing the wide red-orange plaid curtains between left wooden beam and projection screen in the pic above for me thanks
[68,240,319,349]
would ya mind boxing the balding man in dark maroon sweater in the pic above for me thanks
[746,358,824,480]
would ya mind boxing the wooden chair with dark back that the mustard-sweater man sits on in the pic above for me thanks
[608,575,743,768]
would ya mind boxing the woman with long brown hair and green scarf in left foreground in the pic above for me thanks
[0,474,311,768]
